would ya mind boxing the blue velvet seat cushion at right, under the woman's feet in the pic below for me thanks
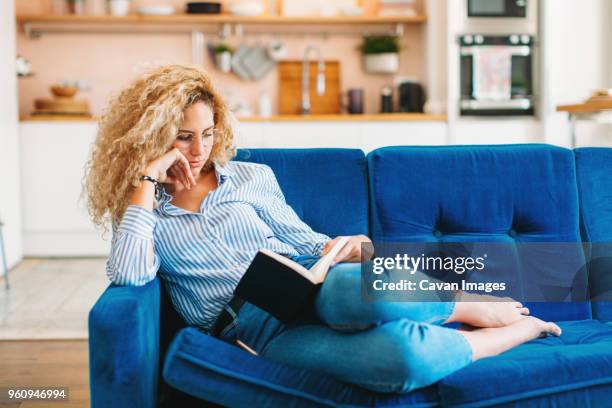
[438,320,612,407]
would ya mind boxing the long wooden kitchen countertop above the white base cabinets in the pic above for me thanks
[20,113,447,122]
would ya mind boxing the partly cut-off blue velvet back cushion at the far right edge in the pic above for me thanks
[574,147,612,322]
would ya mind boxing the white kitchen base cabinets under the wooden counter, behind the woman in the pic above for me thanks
[19,121,446,256]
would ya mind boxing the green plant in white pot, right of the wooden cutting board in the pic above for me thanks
[359,35,399,74]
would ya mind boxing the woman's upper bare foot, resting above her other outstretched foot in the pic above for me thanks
[448,292,529,327]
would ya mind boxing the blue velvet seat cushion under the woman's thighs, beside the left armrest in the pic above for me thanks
[163,328,439,407]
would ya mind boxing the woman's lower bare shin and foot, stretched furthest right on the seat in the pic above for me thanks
[459,316,561,361]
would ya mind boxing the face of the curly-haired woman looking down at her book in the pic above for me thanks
[172,102,215,178]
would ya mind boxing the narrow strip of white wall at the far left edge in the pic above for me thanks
[0,0,22,273]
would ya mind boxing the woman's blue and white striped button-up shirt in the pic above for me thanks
[106,162,330,331]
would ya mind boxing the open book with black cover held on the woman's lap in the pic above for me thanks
[234,237,349,323]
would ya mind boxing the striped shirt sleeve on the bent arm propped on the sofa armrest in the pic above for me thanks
[106,205,160,286]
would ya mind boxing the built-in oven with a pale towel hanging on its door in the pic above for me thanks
[459,34,535,116]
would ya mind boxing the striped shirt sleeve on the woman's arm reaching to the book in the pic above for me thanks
[255,166,330,255]
